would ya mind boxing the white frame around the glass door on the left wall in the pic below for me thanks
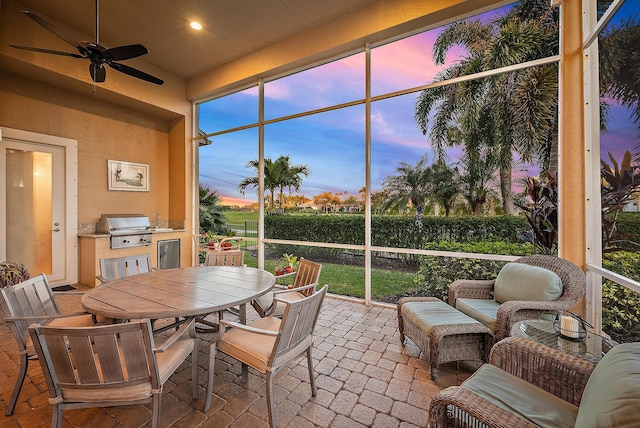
[0,126,78,285]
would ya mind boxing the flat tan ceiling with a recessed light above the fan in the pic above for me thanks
[11,0,376,79]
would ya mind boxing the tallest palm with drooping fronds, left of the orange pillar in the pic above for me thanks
[415,0,558,214]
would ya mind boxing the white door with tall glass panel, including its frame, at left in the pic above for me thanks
[0,128,78,284]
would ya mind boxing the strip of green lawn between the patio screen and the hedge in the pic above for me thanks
[244,253,415,301]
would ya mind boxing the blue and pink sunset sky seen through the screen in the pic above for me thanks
[199,1,640,205]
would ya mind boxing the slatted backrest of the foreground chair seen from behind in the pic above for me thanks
[29,320,160,405]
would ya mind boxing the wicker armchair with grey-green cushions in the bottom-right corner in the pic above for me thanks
[429,337,640,428]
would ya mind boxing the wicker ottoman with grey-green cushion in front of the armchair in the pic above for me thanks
[397,297,493,380]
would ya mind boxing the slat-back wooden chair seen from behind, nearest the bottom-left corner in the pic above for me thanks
[29,319,199,428]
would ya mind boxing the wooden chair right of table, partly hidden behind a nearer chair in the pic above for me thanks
[251,258,322,317]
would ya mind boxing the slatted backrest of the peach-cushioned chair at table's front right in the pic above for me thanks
[268,284,329,367]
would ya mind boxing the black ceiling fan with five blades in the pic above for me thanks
[9,0,164,85]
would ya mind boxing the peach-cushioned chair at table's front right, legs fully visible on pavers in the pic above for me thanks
[204,285,328,428]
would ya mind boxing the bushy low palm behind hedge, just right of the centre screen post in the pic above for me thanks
[382,155,430,213]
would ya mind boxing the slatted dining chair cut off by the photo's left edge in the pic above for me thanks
[0,274,93,416]
